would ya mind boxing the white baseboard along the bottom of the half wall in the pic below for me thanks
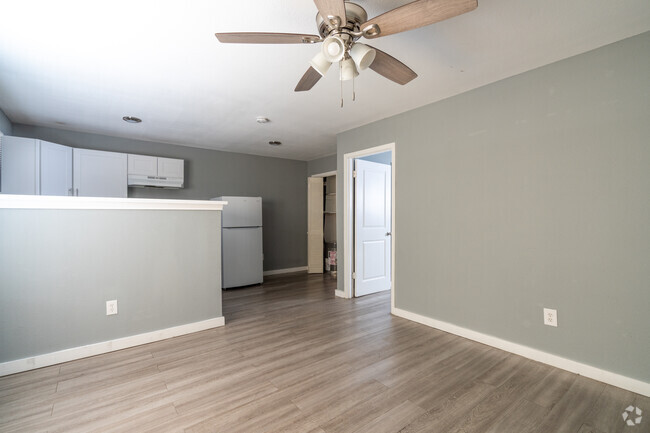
[0,316,226,376]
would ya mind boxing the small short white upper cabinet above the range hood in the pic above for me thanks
[128,154,185,188]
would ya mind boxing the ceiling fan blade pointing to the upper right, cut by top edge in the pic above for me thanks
[360,0,478,38]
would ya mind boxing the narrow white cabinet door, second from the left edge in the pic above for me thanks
[40,141,72,195]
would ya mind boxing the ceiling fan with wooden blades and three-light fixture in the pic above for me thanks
[215,0,478,92]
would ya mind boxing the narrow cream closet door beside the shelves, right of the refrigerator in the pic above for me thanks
[307,177,324,274]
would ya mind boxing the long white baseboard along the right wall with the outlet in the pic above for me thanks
[391,308,650,397]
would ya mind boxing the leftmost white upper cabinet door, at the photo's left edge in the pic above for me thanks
[0,136,40,194]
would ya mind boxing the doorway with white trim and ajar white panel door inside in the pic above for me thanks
[342,143,395,308]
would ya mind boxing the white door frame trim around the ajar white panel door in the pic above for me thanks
[336,142,397,313]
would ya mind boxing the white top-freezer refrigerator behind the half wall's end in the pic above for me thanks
[212,196,264,289]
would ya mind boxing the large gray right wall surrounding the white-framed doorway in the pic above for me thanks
[338,33,650,382]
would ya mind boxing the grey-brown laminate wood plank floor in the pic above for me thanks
[0,274,650,433]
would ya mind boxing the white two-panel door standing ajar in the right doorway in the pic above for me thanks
[354,160,391,296]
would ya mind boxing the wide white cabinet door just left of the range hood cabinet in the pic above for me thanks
[72,149,127,198]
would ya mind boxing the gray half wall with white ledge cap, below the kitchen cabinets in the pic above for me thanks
[0,209,222,362]
